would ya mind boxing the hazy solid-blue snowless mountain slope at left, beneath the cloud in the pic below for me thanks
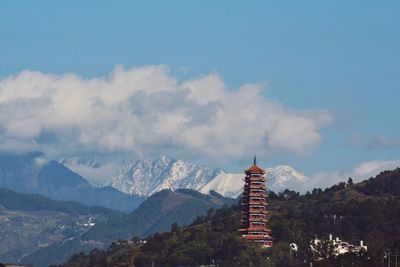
[0,152,143,212]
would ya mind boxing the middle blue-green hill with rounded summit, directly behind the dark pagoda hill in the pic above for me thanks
[23,189,236,266]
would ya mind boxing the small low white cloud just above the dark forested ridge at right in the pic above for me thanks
[307,160,400,190]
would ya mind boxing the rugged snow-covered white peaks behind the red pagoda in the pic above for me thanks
[62,157,308,197]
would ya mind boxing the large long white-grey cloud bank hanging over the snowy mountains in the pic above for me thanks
[0,66,332,160]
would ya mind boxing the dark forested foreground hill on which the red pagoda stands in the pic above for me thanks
[61,169,400,267]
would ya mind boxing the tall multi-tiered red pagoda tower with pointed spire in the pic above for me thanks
[239,156,273,247]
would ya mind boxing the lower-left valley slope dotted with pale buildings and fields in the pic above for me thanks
[0,188,122,262]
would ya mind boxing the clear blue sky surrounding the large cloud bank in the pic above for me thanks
[0,1,400,179]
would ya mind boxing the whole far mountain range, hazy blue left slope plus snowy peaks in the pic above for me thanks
[0,152,307,212]
